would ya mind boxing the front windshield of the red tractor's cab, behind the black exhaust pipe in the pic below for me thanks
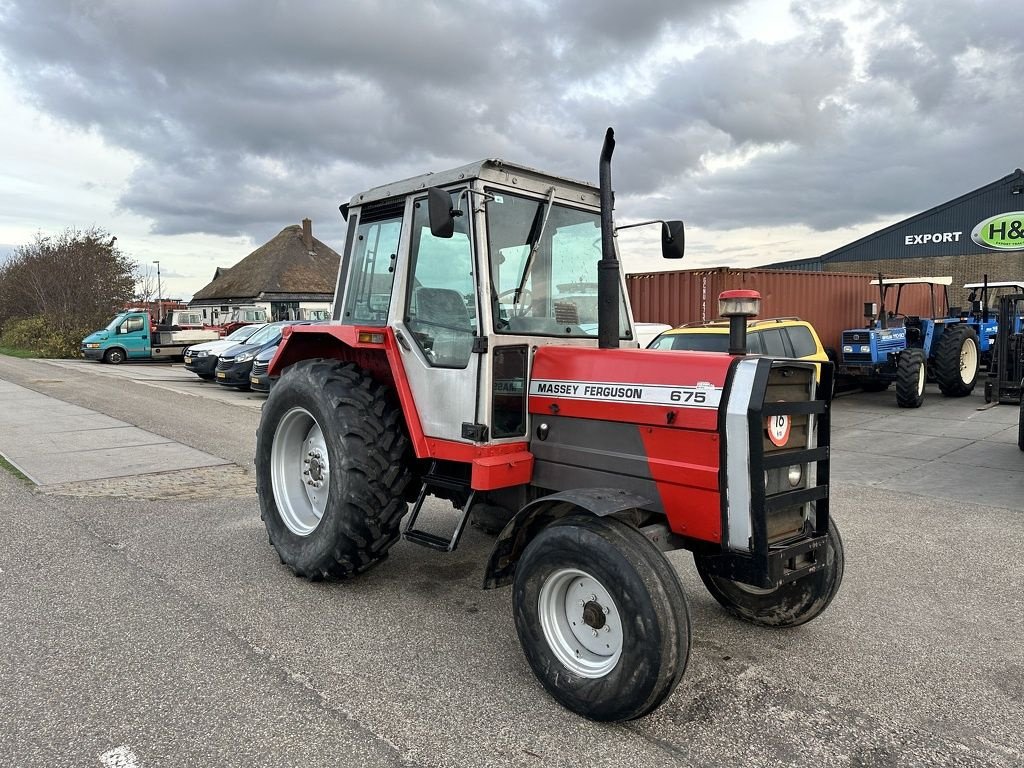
[487,189,632,339]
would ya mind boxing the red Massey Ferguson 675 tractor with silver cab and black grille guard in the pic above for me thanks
[256,129,843,721]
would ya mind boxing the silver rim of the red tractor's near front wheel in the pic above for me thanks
[538,568,623,678]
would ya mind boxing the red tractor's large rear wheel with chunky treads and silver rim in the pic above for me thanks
[256,360,411,580]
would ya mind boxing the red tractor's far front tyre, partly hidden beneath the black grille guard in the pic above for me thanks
[693,520,846,627]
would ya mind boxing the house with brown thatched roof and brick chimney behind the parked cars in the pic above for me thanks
[190,219,341,319]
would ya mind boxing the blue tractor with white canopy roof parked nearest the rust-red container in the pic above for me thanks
[839,275,979,408]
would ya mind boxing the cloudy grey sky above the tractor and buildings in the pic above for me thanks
[0,0,1024,297]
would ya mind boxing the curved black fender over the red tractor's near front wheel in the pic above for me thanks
[483,488,656,589]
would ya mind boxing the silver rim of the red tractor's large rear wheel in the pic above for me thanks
[270,408,331,536]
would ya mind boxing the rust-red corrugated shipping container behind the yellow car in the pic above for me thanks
[626,267,946,349]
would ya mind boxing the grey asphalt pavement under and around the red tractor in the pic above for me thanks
[0,357,1024,767]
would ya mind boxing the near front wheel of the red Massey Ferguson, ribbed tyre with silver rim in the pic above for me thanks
[512,515,690,722]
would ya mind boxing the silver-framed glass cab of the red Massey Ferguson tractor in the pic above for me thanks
[286,155,683,443]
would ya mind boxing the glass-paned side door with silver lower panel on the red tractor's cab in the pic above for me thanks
[396,190,486,441]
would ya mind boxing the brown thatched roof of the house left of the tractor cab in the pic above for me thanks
[193,224,341,303]
